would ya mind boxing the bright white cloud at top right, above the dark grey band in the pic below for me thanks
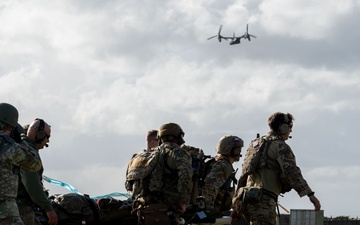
[260,0,355,40]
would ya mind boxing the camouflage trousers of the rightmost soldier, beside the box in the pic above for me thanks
[244,194,276,225]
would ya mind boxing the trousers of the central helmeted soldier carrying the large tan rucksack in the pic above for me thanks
[137,203,178,225]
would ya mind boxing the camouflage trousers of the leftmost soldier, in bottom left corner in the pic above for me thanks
[0,199,24,225]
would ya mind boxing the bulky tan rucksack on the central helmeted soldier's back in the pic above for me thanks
[125,147,164,198]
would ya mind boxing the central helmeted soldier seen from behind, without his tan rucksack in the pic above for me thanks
[137,123,193,225]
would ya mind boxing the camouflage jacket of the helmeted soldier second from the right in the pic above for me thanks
[202,157,235,211]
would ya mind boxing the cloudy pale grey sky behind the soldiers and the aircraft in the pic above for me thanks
[0,0,360,217]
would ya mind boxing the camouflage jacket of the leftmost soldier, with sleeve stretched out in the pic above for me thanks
[0,133,41,200]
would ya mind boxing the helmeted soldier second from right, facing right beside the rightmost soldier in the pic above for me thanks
[202,135,244,215]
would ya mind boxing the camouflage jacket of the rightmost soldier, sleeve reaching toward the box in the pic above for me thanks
[246,132,312,197]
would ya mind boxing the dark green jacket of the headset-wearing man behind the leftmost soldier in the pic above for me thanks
[17,134,52,212]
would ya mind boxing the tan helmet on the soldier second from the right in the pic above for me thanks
[216,135,244,156]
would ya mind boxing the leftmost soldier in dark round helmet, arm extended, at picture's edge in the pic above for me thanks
[0,103,41,225]
